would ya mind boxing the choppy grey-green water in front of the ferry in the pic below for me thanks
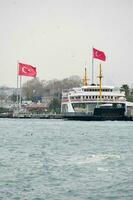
[0,119,133,200]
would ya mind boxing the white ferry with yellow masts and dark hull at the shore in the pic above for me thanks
[61,65,126,120]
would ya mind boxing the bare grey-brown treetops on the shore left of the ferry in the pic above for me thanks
[22,76,82,101]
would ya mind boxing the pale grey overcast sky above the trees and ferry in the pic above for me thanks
[0,0,133,87]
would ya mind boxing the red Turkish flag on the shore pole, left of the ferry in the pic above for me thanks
[18,63,37,77]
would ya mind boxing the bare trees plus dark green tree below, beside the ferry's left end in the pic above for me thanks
[22,76,82,113]
